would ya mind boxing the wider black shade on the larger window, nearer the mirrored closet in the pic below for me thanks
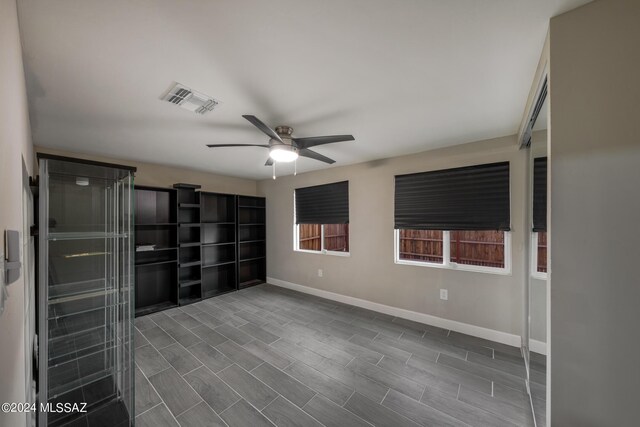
[395,162,511,231]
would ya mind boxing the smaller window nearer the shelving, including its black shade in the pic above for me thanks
[294,181,349,255]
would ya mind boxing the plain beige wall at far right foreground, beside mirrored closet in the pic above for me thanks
[550,0,640,426]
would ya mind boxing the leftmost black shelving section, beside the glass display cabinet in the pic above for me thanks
[134,186,178,316]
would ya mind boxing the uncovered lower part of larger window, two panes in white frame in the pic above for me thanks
[396,229,510,273]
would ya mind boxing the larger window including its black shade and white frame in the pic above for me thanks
[395,162,511,274]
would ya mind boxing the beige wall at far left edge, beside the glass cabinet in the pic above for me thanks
[0,0,33,426]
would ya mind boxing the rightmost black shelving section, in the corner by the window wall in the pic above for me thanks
[236,196,267,289]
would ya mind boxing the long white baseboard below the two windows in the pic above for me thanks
[267,277,522,348]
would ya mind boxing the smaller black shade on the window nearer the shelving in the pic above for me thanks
[296,181,349,224]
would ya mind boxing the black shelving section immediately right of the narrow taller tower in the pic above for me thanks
[200,192,237,298]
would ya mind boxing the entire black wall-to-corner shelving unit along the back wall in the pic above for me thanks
[135,184,266,316]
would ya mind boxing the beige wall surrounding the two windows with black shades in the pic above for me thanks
[258,136,527,335]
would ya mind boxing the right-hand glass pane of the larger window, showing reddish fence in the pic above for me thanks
[450,231,504,268]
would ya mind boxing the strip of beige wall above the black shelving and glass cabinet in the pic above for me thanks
[35,147,257,196]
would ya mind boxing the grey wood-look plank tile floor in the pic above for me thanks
[135,285,544,427]
